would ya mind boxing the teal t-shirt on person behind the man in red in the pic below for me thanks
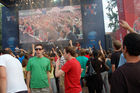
[76,56,88,77]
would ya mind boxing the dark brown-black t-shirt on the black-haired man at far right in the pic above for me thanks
[111,62,140,93]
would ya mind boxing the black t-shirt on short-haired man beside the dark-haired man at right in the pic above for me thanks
[111,51,122,69]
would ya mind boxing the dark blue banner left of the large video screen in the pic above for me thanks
[2,7,19,51]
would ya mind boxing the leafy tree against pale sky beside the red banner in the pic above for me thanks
[106,0,119,32]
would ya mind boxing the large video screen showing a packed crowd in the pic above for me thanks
[19,5,83,43]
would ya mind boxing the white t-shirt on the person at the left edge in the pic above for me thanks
[0,54,27,93]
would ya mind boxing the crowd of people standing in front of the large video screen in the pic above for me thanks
[0,21,140,93]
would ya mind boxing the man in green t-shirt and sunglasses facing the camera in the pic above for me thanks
[26,44,51,93]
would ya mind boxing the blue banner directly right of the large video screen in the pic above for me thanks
[82,0,105,48]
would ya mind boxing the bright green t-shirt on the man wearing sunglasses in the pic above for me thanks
[26,57,50,88]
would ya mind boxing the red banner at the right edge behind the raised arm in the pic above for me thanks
[116,0,140,41]
